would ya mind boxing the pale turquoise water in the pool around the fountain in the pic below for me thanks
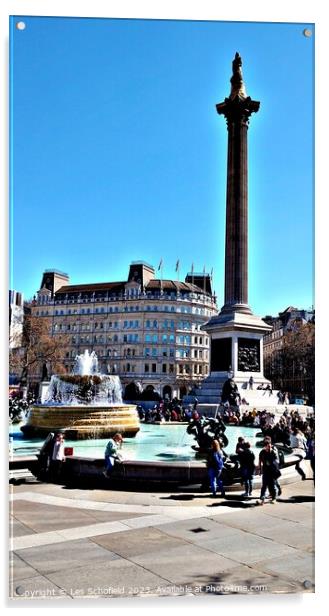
[9,422,258,462]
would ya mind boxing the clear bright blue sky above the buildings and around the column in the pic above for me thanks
[10,16,314,315]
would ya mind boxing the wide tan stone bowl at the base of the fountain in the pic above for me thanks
[21,404,140,440]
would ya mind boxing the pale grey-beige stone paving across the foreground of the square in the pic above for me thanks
[9,464,314,599]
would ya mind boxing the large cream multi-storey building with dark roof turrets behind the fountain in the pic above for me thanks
[32,261,217,398]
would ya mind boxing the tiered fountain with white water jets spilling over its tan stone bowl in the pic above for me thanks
[21,350,140,440]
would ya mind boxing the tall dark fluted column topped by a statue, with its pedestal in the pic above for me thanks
[197,53,271,403]
